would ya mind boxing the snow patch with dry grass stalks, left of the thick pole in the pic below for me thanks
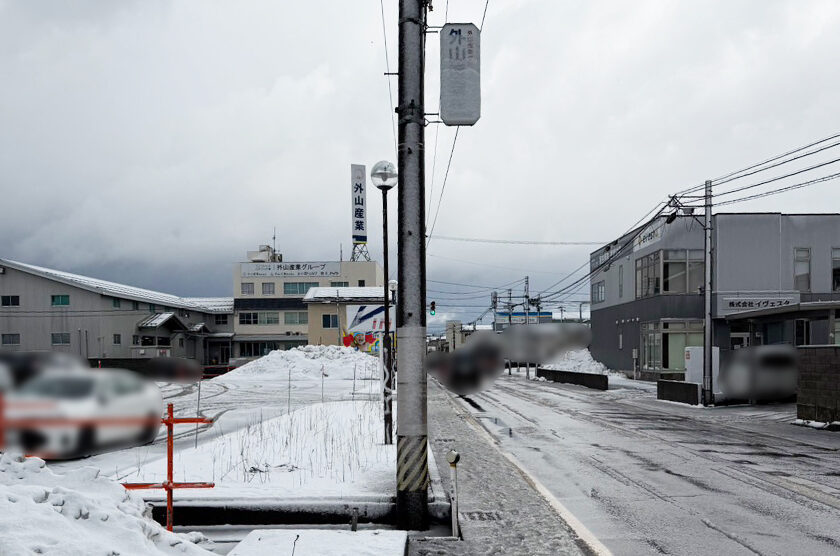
[126,401,396,500]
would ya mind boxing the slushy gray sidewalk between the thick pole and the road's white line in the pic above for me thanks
[409,380,590,556]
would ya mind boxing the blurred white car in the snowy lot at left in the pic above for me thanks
[6,369,163,459]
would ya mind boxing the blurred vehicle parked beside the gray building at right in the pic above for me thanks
[720,344,799,402]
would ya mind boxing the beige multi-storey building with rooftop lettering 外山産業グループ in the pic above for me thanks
[233,246,384,358]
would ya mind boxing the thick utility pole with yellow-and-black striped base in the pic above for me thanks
[397,0,429,531]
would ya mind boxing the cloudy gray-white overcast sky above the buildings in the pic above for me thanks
[0,0,840,326]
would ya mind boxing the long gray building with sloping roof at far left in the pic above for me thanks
[0,259,233,366]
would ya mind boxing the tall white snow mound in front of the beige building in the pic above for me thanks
[214,346,379,382]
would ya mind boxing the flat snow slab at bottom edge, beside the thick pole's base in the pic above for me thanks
[229,529,408,556]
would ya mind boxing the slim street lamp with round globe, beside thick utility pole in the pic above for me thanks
[370,160,397,444]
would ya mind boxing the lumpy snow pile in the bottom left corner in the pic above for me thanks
[0,453,212,556]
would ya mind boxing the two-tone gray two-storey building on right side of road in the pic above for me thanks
[590,213,840,375]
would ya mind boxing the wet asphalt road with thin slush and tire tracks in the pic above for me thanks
[462,375,840,555]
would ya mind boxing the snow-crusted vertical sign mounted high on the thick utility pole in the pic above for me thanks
[440,23,481,125]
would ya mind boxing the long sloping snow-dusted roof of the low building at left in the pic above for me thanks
[0,259,233,313]
